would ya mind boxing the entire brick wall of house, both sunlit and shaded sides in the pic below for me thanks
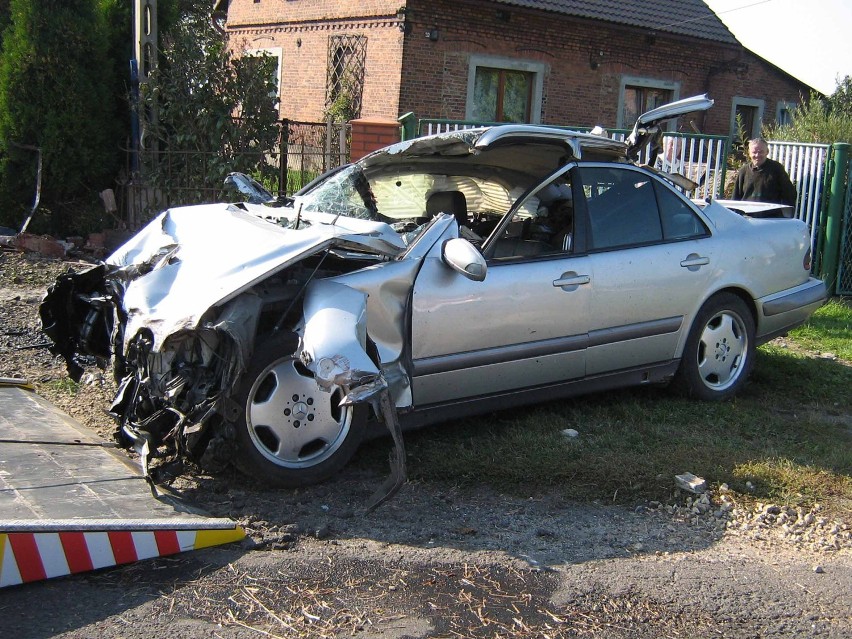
[223,0,809,134]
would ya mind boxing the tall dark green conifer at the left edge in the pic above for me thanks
[0,0,118,232]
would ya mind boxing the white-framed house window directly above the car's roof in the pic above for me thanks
[465,56,544,123]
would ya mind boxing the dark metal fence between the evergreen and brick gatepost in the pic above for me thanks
[116,120,351,229]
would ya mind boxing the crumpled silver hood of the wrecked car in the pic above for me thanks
[107,204,405,350]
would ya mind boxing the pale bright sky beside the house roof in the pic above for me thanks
[704,0,852,95]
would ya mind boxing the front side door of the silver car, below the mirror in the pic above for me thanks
[411,172,590,407]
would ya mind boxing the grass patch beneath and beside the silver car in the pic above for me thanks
[360,299,852,519]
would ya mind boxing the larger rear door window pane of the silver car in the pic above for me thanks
[580,167,663,250]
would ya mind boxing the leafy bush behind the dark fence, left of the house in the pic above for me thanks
[142,3,278,200]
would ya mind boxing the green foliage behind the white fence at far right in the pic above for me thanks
[763,76,852,144]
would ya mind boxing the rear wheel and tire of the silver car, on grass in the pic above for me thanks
[676,293,755,401]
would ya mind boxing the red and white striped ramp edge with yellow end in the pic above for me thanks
[0,519,245,587]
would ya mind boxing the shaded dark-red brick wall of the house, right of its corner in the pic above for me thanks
[399,0,809,134]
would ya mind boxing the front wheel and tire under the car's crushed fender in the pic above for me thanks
[233,337,367,488]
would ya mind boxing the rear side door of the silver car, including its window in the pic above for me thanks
[576,164,714,375]
